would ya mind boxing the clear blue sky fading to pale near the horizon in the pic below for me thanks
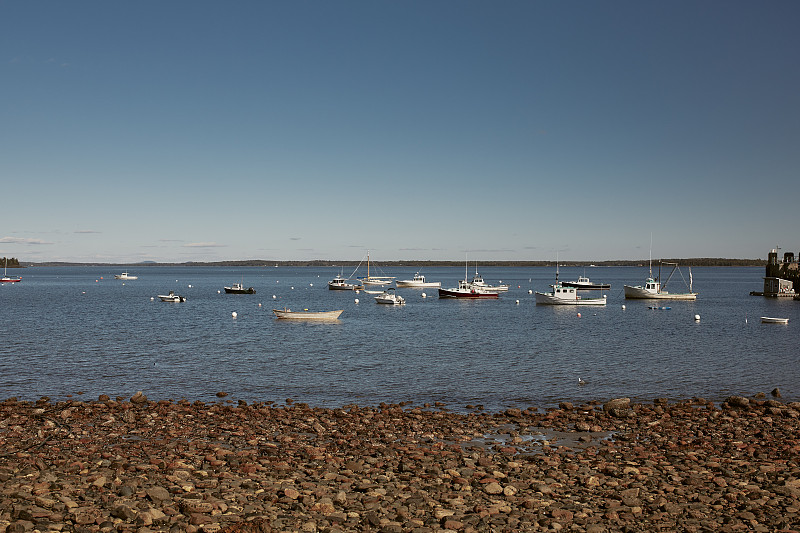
[0,0,800,262]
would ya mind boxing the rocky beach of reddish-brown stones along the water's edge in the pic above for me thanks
[0,391,800,533]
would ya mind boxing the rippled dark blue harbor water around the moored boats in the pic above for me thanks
[0,267,800,410]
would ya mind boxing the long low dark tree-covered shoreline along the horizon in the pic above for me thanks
[21,257,767,269]
